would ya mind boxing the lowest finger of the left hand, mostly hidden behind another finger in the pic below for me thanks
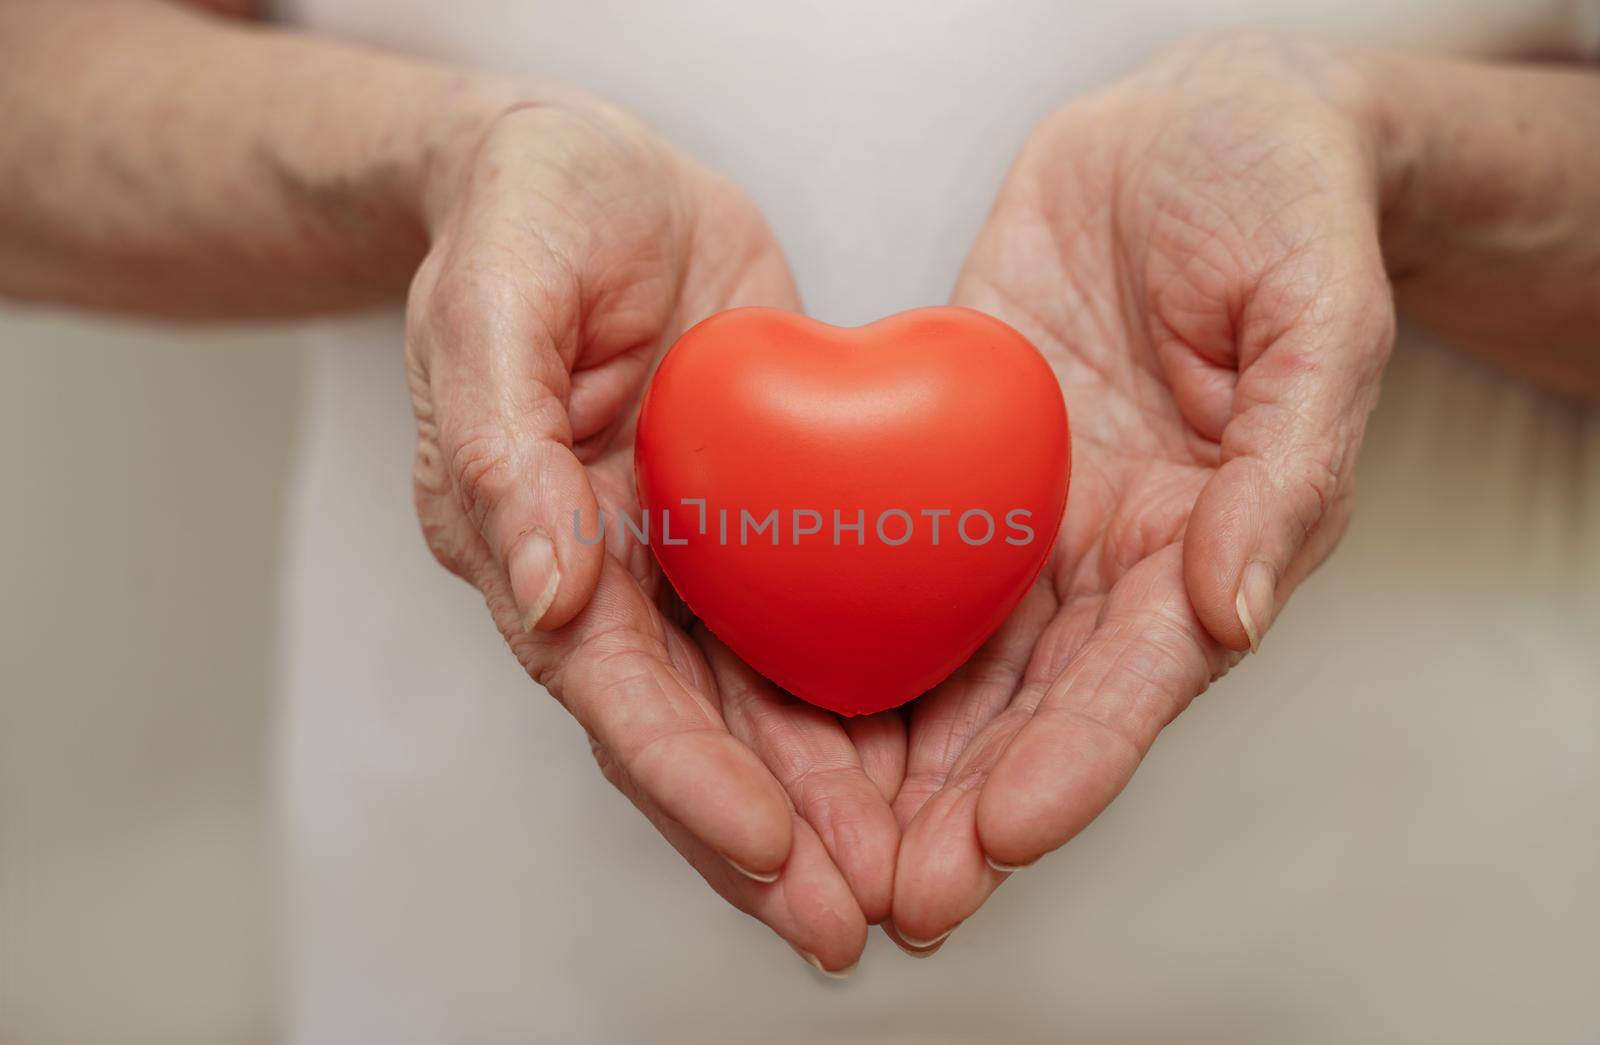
[595,732,867,976]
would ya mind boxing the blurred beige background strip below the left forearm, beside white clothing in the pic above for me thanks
[0,306,302,1045]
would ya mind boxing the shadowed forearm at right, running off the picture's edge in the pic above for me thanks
[1363,48,1600,397]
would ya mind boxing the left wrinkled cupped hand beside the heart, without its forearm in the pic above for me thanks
[406,96,904,971]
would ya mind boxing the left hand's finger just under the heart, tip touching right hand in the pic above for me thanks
[710,629,899,922]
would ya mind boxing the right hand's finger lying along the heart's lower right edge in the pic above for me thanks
[894,578,1056,826]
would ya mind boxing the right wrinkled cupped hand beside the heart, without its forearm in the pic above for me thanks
[893,37,1394,954]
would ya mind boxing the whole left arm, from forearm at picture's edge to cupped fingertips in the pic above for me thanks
[0,2,906,970]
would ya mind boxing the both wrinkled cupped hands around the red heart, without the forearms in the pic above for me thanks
[408,40,1394,971]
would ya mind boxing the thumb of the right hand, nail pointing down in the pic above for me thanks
[1184,259,1394,650]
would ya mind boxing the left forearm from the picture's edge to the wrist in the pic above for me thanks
[0,0,515,315]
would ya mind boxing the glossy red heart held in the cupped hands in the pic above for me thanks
[634,307,1070,715]
